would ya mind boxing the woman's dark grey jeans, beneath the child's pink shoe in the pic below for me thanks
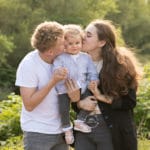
[75,115,113,150]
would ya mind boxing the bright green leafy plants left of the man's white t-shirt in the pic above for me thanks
[0,93,22,141]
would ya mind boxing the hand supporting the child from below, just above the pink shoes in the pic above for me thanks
[77,96,97,111]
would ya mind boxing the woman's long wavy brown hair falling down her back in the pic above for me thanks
[92,20,140,97]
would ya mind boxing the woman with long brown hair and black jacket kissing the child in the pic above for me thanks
[66,20,139,150]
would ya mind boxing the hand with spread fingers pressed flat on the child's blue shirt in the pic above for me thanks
[65,79,80,102]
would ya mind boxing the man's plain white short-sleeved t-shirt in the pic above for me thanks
[15,50,62,134]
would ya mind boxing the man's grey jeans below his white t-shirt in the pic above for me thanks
[24,132,69,150]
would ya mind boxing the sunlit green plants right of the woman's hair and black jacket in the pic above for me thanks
[135,64,150,139]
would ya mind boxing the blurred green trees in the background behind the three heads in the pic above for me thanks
[0,0,150,90]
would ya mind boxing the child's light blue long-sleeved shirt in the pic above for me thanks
[53,52,98,94]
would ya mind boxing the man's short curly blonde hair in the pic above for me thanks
[31,21,64,52]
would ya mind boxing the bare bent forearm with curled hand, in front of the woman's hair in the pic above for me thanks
[88,81,112,104]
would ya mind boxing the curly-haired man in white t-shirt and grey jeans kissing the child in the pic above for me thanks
[16,22,68,150]
